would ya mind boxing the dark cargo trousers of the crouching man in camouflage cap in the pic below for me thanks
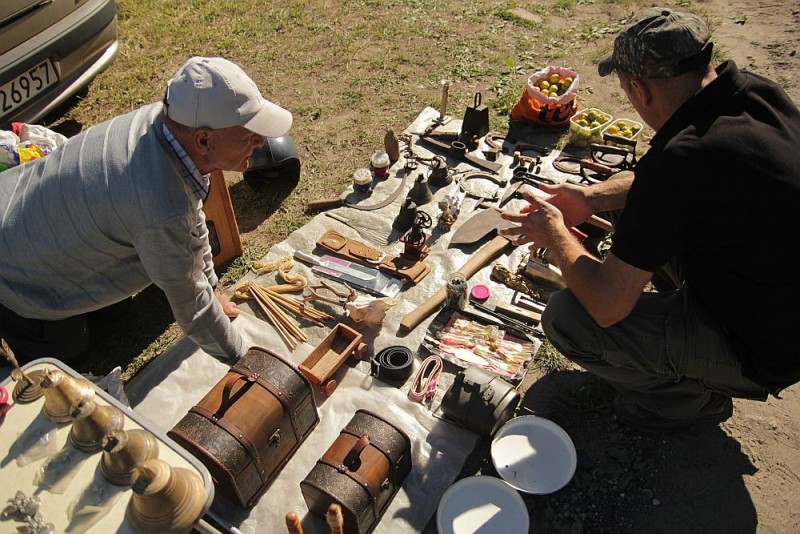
[542,286,767,420]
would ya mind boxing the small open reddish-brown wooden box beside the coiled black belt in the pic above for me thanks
[299,323,367,395]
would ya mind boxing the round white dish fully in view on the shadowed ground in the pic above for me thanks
[491,415,578,495]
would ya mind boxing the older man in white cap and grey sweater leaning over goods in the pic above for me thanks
[0,57,292,362]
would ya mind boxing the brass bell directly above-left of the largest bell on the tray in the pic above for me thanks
[100,428,158,486]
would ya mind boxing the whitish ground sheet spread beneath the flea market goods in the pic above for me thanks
[125,108,540,533]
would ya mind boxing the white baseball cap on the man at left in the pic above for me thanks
[165,57,292,137]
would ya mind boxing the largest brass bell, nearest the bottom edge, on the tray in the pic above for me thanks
[125,458,205,534]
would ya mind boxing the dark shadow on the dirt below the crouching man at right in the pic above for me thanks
[434,371,758,534]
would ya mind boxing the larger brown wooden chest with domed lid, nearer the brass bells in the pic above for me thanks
[167,347,319,508]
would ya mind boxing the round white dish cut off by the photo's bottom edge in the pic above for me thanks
[436,475,530,534]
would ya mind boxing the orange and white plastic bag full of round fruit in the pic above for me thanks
[511,66,579,126]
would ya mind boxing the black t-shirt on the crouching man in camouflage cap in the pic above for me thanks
[611,61,800,389]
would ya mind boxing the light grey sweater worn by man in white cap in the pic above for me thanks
[0,103,245,358]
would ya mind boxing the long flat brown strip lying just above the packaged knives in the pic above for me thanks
[317,228,431,283]
